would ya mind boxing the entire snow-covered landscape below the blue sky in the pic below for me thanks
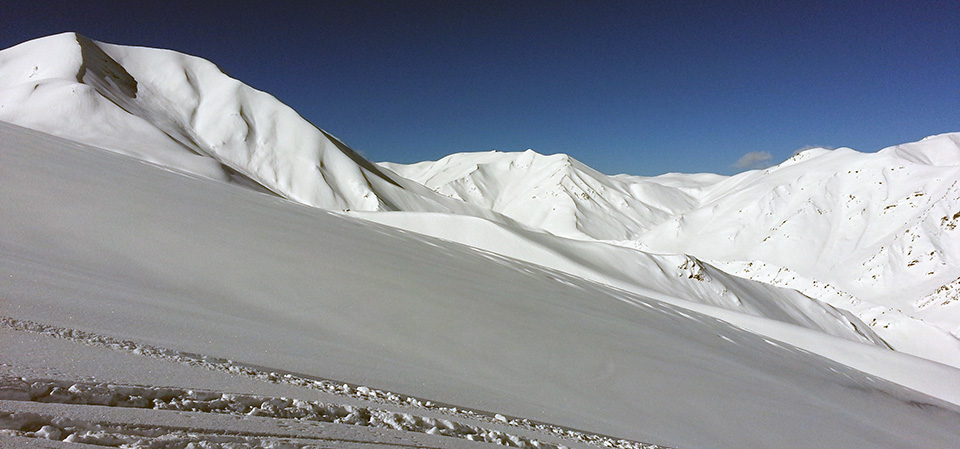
[0,33,960,448]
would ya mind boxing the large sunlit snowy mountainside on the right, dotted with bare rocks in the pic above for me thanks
[635,133,960,366]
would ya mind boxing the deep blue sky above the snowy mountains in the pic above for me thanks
[0,0,960,175]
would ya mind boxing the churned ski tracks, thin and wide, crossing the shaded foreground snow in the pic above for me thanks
[0,316,664,449]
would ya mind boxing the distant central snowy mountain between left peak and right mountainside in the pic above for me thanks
[381,150,715,240]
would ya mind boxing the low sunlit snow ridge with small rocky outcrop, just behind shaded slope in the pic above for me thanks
[353,212,888,347]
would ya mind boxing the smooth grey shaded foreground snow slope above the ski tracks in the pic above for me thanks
[0,124,960,448]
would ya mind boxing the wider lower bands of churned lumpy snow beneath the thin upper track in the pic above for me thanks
[0,377,576,449]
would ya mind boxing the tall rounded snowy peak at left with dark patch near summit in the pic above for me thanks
[0,33,502,223]
